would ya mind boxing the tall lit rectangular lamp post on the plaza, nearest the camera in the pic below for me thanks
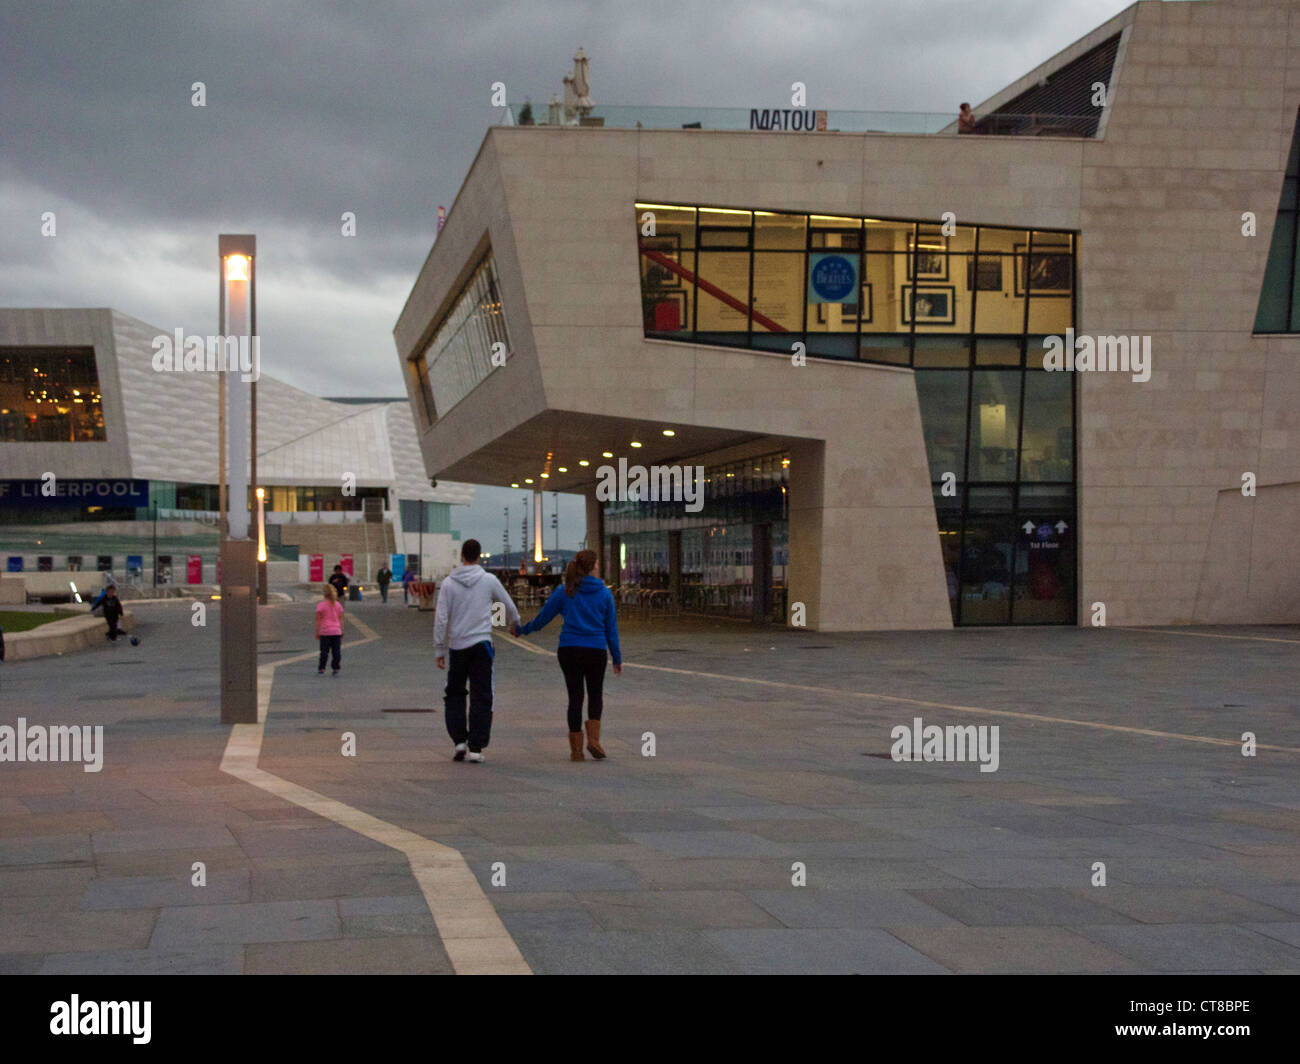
[217,234,260,725]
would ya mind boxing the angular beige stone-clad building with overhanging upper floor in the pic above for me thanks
[395,0,1300,631]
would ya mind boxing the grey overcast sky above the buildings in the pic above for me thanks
[0,0,1128,546]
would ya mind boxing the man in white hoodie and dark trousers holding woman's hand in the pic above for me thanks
[433,540,519,764]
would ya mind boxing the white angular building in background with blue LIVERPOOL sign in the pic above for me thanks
[0,308,475,579]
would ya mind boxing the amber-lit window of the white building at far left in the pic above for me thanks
[0,347,105,444]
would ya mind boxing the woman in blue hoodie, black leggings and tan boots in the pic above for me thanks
[515,550,623,761]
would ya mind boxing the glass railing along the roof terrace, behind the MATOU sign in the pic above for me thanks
[498,104,1101,137]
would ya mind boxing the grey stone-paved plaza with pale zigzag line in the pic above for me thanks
[0,601,1300,974]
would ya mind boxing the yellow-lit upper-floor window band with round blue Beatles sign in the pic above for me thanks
[636,203,1076,366]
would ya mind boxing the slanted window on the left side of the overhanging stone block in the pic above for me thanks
[412,252,510,423]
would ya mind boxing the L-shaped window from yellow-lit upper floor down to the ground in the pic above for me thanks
[637,203,1078,624]
